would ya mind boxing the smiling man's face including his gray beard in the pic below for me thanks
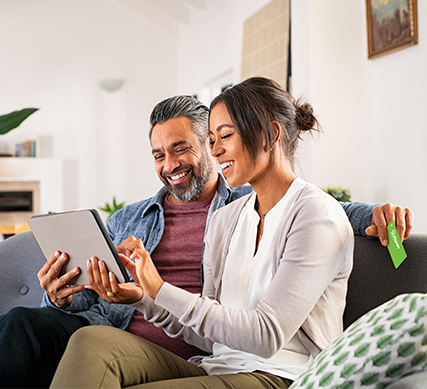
[151,117,213,203]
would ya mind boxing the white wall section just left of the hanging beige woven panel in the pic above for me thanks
[178,0,270,99]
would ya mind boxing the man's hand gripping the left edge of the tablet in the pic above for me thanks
[37,251,84,308]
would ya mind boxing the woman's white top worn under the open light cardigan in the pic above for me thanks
[200,178,313,379]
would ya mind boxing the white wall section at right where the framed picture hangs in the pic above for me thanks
[292,0,427,232]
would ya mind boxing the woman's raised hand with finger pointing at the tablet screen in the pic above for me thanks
[116,236,164,299]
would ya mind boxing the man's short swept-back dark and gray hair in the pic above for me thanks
[148,95,209,145]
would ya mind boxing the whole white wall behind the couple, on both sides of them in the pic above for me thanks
[0,0,427,232]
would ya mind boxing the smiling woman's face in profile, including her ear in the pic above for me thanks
[209,103,266,188]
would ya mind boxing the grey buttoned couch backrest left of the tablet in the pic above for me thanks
[0,231,46,315]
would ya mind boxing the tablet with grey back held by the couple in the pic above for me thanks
[28,209,129,285]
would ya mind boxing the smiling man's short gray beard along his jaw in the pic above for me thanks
[165,155,212,203]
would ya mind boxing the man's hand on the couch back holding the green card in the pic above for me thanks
[365,203,414,246]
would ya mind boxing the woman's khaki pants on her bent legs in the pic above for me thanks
[51,326,292,389]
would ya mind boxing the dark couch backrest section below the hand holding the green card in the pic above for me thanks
[344,234,427,328]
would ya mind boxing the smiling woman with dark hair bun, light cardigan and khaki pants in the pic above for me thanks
[52,78,353,388]
